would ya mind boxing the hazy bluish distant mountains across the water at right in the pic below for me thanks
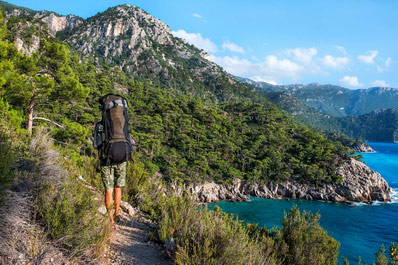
[239,78,398,142]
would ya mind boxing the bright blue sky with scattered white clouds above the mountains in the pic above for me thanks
[8,0,398,89]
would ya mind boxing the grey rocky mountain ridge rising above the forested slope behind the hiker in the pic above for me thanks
[0,2,270,105]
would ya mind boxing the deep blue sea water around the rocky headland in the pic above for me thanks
[210,142,398,264]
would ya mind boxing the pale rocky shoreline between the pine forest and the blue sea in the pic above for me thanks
[172,159,391,204]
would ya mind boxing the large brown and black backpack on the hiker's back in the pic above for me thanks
[93,94,136,165]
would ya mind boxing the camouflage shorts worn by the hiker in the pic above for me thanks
[101,162,127,190]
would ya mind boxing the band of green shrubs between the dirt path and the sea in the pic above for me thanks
[125,160,339,265]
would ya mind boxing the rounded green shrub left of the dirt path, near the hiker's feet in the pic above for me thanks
[36,176,108,256]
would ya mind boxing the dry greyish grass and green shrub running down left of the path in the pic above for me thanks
[30,128,109,260]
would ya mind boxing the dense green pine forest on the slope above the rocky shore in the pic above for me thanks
[130,84,347,182]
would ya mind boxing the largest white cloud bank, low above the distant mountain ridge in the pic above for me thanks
[212,55,305,83]
